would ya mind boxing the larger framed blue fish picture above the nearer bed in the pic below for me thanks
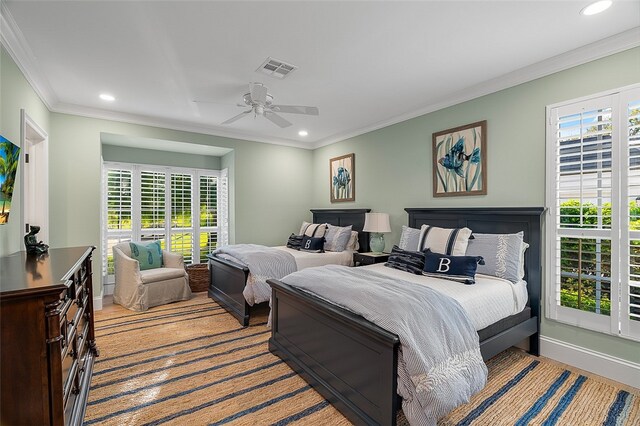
[432,120,487,197]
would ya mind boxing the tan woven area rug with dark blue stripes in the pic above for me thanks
[84,293,640,426]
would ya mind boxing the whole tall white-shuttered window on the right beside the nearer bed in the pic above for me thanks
[547,87,640,339]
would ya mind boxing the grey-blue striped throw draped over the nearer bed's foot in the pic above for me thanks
[282,265,487,426]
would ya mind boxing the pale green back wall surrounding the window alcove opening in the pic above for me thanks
[50,113,313,292]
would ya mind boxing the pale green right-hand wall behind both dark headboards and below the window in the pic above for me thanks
[313,48,640,362]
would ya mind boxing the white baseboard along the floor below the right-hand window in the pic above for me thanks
[540,336,640,387]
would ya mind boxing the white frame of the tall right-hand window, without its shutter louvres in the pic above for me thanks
[545,84,640,340]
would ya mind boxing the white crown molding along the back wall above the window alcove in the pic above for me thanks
[50,103,313,149]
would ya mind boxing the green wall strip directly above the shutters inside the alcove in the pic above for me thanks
[102,144,220,170]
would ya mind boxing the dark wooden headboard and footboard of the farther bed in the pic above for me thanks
[207,209,371,326]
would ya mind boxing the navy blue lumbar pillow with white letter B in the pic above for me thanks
[422,249,484,284]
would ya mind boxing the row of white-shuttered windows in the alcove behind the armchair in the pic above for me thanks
[102,162,228,282]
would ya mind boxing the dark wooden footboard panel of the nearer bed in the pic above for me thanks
[267,280,399,425]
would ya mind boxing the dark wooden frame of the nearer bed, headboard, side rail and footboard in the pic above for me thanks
[268,207,544,425]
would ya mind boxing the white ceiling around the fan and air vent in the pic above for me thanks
[0,0,640,148]
